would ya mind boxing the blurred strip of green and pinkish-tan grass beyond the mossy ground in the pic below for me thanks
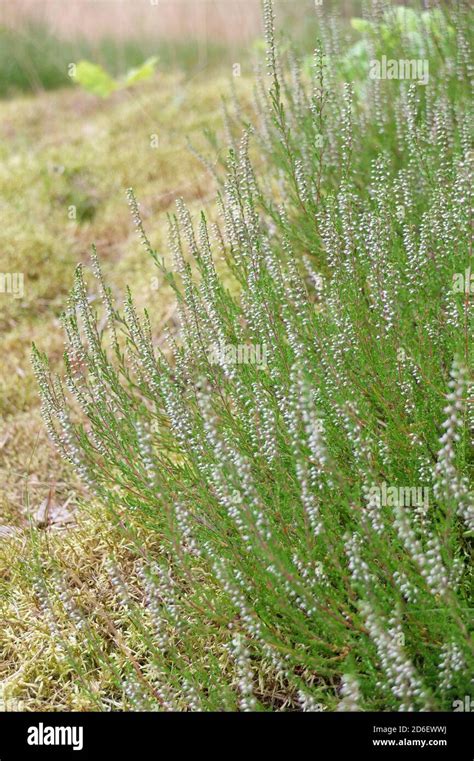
[0,0,368,97]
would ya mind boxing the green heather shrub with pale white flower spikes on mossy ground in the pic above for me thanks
[34,3,474,711]
